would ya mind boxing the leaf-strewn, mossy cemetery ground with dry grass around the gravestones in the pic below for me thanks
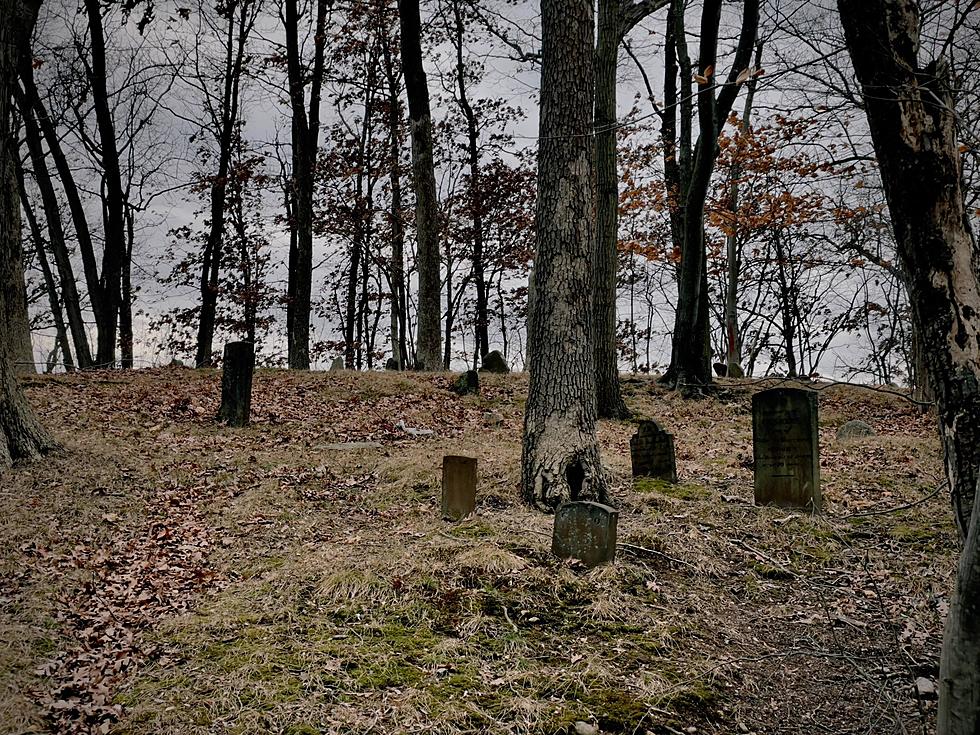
[0,368,957,735]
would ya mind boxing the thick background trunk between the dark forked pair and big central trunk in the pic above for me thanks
[398,0,442,370]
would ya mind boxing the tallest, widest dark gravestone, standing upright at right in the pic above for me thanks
[752,388,822,510]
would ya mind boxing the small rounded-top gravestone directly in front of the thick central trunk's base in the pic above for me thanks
[551,500,619,568]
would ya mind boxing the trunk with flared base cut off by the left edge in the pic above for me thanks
[0,0,55,472]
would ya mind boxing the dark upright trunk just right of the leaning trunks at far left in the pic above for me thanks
[83,0,126,368]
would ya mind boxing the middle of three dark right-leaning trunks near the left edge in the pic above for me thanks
[14,85,92,369]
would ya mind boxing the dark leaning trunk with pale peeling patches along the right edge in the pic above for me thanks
[838,0,980,735]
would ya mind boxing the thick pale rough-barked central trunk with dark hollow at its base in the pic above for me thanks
[521,0,606,510]
